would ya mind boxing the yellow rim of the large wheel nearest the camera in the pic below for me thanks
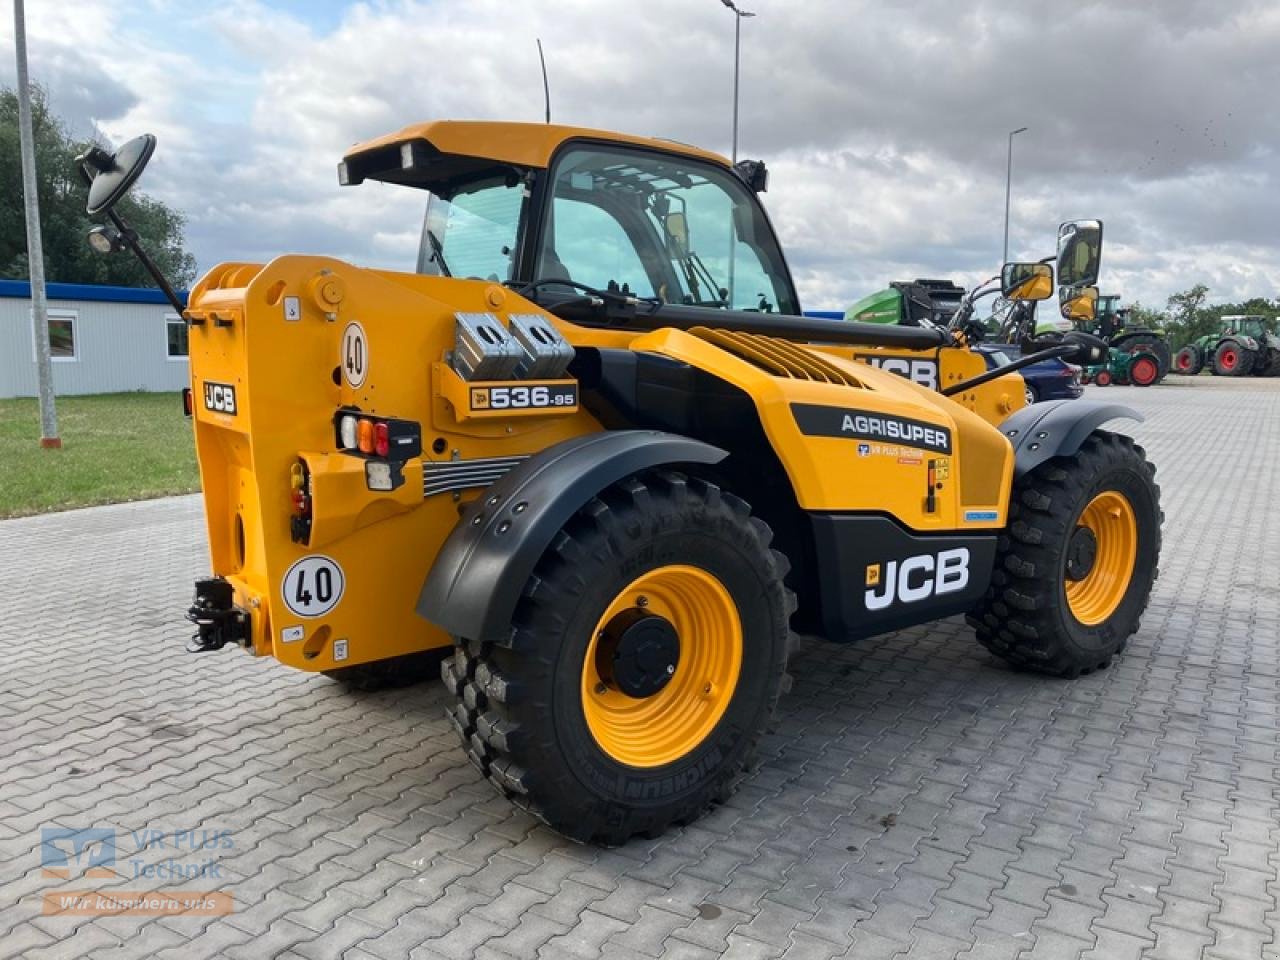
[582,564,742,767]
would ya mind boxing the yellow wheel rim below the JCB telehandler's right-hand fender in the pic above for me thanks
[1066,490,1138,627]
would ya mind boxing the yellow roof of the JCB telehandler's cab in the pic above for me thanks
[338,120,730,189]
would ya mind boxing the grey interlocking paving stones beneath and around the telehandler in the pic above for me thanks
[0,376,1280,960]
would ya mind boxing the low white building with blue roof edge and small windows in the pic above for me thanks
[0,280,191,397]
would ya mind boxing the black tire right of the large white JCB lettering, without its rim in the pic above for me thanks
[968,430,1164,677]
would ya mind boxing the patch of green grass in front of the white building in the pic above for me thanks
[0,393,200,517]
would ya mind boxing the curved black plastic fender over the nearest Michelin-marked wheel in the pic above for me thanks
[417,430,728,641]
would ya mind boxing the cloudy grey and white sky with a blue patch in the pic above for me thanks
[0,0,1280,308]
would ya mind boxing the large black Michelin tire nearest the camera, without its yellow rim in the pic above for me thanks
[442,470,795,845]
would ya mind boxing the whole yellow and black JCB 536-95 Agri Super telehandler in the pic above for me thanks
[82,122,1161,844]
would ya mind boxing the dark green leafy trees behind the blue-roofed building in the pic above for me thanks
[0,87,196,288]
